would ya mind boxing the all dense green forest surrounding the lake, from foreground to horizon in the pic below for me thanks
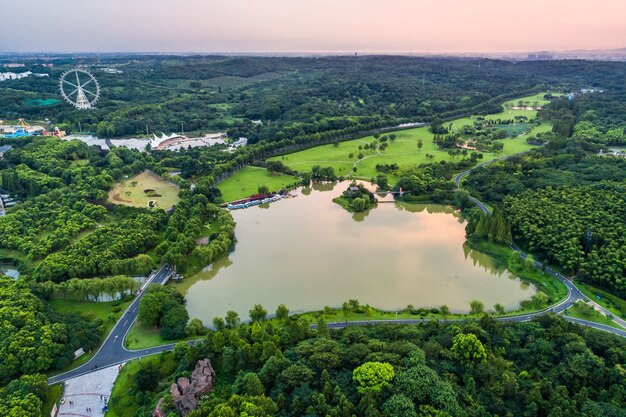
[0,56,626,416]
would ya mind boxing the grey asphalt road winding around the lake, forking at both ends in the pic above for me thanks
[48,152,626,384]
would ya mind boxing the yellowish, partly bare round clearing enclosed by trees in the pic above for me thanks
[109,171,179,209]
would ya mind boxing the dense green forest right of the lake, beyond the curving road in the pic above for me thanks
[465,93,626,297]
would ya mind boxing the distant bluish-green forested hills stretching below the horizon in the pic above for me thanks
[0,56,626,142]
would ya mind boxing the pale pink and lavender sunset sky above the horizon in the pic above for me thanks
[0,0,626,54]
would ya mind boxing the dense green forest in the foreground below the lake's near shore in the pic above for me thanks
[111,310,626,417]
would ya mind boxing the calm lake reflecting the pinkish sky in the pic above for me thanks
[178,183,535,324]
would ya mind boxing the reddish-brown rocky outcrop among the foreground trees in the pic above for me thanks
[165,359,215,417]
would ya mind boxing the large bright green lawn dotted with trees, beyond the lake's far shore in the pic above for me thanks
[268,93,551,183]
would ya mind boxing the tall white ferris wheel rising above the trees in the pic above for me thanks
[59,68,100,110]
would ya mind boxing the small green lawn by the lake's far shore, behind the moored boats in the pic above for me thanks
[217,166,298,201]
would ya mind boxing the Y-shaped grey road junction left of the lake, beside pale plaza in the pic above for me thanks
[48,265,174,384]
